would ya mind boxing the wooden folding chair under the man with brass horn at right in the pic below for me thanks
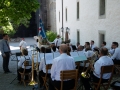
[93,65,114,90]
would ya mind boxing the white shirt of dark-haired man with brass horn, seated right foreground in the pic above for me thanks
[93,56,113,79]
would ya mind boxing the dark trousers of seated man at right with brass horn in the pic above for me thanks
[81,74,108,90]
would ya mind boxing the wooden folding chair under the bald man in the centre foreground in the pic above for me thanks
[55,69,78,90]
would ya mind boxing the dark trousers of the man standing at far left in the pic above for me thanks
[2,52,10,72]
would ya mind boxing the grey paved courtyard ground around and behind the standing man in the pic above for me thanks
[0,37,120,90]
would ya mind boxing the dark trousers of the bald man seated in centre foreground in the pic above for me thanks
[49,78,75,90]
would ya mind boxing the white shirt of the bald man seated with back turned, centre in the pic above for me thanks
[51,53,75,81]
